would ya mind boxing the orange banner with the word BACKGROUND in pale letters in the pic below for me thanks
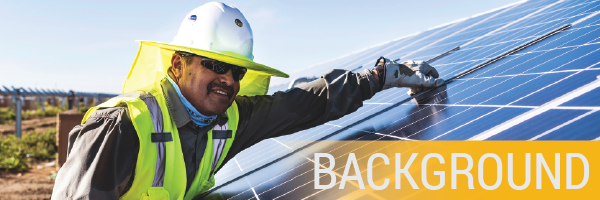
[305,141,600,199]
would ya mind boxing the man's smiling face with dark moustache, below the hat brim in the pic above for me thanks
[171,54,240,116]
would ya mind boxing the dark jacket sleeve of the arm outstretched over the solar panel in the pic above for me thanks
[226,69,380,160]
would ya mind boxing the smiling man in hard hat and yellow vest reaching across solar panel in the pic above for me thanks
[52,2,443,199]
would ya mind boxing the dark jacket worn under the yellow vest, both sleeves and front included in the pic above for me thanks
[52,70,379,199]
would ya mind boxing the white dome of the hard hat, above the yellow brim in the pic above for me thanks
[171,2,254,60]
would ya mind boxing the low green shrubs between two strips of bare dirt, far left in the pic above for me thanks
[0,130,58,171]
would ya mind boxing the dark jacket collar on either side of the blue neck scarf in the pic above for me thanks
[160,77,228,128]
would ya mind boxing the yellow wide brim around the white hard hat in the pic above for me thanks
[137,40,290,78]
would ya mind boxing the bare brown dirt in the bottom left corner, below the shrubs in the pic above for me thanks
[0,163,56,200]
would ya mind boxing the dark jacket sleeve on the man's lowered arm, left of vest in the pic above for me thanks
[52,108,139,199]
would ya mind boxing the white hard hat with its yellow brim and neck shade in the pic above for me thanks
[123,2,289,96]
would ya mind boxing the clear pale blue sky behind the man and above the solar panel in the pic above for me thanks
[0,0,517,93]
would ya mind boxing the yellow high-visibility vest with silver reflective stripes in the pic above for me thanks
[82,81,239,200]
